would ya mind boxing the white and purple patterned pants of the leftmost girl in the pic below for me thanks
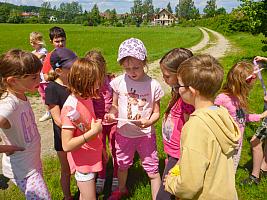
[11,172,51,200]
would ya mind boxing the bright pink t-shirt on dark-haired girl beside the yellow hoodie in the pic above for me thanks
[162,98,194,159]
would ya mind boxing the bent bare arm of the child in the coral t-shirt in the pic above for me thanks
[61,119,102,152]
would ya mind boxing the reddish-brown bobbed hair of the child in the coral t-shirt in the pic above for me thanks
[68,58,104,98]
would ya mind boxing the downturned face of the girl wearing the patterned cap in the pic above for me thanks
[122,57,145,81]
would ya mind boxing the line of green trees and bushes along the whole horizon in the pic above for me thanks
[0,0,267,51]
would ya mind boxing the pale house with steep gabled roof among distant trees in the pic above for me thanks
[152,8,177,26]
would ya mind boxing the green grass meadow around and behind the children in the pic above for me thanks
[0,24,267,200]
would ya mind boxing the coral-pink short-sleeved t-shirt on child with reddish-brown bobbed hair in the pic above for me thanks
[61,95,103,173]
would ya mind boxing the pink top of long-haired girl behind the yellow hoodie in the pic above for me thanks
[214,93,261,134]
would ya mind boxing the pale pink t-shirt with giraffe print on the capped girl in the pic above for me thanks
[110,74,164,138]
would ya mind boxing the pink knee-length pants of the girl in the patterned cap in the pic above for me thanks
[115,133,159,174]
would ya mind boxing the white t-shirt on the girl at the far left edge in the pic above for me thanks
[0,93,41,179]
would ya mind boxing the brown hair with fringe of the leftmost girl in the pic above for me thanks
[0,49,42,98]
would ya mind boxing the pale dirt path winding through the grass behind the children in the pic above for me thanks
[0,28,230,164]
